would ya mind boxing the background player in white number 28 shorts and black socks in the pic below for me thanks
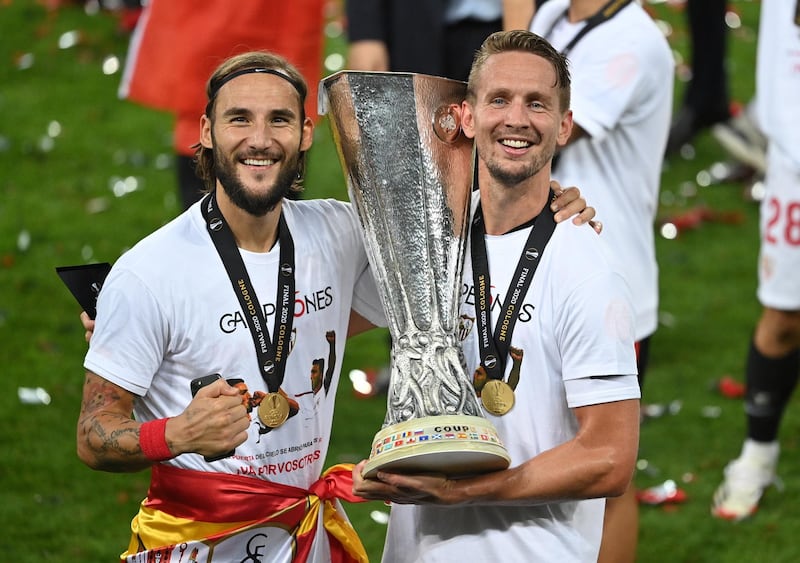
[711,0,800,521]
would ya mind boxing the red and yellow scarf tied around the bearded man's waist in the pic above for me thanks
[121,464,367,563]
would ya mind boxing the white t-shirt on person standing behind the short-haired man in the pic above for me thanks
[531,0,674,340]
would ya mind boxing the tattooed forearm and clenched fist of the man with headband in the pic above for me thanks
[77,371,249,472]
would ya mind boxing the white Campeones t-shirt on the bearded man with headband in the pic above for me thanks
[84,200,383,488]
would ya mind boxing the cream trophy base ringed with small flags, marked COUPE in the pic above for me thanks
[363,415,511,479]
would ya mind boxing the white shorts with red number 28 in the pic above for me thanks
[757,144,800,311]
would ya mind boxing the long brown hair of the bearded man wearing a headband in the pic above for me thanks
[192,51,308,195]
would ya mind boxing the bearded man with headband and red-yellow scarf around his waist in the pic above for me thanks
[77,52,593,562]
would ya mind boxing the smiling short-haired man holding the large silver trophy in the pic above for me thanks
[354,31,639,563]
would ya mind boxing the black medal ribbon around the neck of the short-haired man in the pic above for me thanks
[470,193,556,379]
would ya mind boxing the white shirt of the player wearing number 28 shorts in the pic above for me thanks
[756,0,800,170]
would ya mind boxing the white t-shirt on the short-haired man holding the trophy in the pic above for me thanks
[383,193,639,563]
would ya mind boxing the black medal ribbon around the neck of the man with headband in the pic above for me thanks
[201,192,294,393]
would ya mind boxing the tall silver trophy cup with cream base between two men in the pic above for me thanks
[320,71,510,477]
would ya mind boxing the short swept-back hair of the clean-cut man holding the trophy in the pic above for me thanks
[467,30,571,111]
